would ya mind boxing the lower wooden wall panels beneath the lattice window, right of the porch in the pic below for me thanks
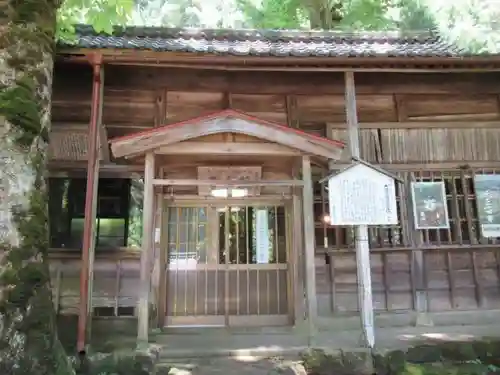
[316,248,500,316]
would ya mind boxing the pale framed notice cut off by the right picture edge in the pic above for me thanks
[474,174,500,237]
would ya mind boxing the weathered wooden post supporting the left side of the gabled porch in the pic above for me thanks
[137,152,155,344]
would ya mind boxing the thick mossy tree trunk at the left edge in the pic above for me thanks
[0,0,74,375]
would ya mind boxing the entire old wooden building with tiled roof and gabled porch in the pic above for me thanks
[49,26,500,347]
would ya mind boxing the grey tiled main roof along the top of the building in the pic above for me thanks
[62,25,462,57]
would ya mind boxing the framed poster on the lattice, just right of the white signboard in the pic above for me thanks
[411,181,450,229]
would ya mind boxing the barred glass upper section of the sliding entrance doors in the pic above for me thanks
[168,206,287,269]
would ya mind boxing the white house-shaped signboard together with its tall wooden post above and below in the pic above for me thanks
[328,72,398,348]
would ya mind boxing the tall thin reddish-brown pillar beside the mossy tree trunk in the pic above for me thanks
[77,54,103,353]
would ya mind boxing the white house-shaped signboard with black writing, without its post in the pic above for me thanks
[328,164,398,225]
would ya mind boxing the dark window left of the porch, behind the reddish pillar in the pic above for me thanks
[49,178,142,249]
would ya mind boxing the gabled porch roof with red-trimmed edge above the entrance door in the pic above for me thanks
[110,109,344,160]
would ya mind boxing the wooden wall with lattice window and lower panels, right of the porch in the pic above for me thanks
[316,165,500,314]
